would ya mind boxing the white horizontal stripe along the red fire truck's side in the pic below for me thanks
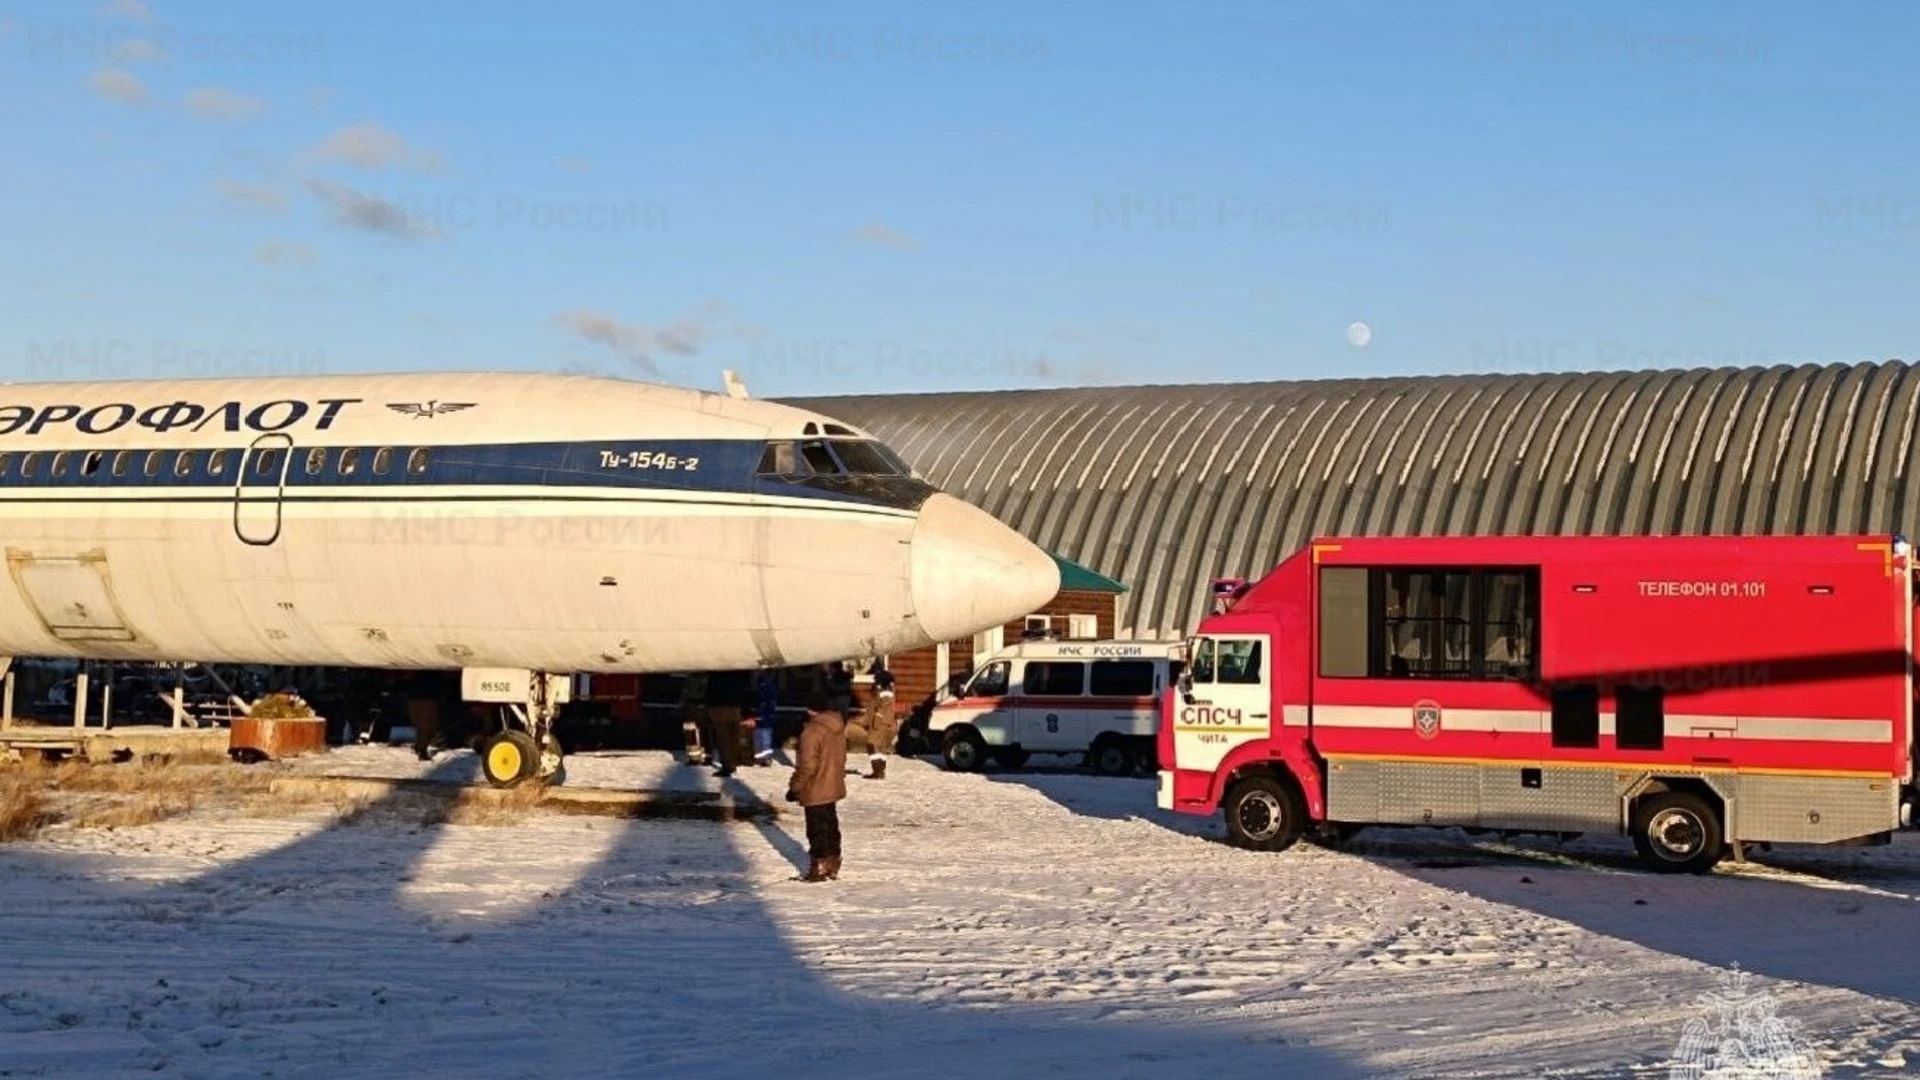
[1284,705,1893,742]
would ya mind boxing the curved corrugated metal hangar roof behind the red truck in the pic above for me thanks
[789,361,1920,638]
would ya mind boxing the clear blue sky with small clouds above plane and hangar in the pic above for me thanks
[0,0,1920,396]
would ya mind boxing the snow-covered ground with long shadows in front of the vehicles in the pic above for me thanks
[0,748,1920,1080]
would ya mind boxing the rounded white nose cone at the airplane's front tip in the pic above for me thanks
[912,496,1060,642]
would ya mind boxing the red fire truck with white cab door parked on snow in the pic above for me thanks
[1158,536,1914,872]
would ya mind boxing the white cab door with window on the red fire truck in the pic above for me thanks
[1173,634,1273,773]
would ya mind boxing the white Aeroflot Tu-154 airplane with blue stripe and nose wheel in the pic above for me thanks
[0,373,1060,786]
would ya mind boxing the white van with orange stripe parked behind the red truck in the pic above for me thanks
[927,642,1181,776]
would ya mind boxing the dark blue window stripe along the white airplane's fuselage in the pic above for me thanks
[0,432,933,509]
